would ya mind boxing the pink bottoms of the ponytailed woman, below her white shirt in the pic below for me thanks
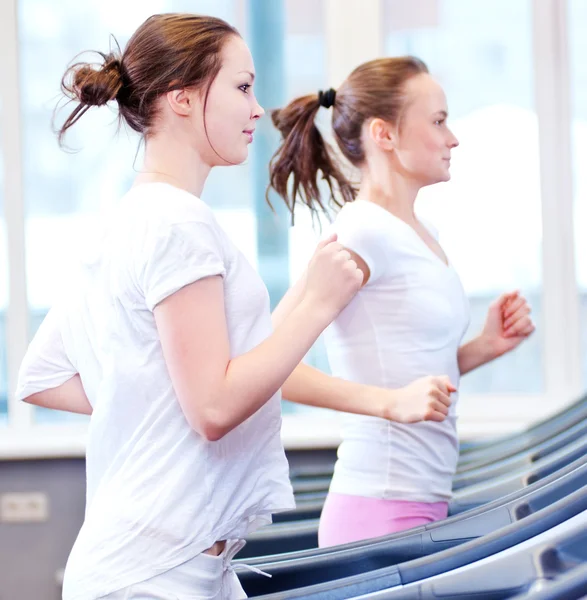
[318,493,448,548]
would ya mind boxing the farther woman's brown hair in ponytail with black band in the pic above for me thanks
[267,56,428,221]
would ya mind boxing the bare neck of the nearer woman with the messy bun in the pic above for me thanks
[134,133,211,197]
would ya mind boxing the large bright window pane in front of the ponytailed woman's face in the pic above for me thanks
[384,0,543,393]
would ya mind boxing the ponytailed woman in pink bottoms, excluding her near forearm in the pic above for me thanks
[270,57,534,546]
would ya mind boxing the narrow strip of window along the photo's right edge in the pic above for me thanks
[569,0,587,385]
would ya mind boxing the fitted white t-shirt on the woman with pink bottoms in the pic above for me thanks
[325,200,469,502]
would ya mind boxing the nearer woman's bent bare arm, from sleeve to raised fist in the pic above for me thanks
[154,238,360,440]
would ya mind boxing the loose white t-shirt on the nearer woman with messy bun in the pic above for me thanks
[18,183,294,600]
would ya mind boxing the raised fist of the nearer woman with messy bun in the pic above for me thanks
[304,234,363,323]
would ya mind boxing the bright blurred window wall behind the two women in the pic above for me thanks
[0,0,587,600]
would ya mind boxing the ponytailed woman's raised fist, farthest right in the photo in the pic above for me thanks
[480,291,536,358]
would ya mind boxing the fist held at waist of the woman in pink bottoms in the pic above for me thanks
[383,375,457,423]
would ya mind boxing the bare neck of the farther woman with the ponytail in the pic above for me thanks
[359,159,420,224]
